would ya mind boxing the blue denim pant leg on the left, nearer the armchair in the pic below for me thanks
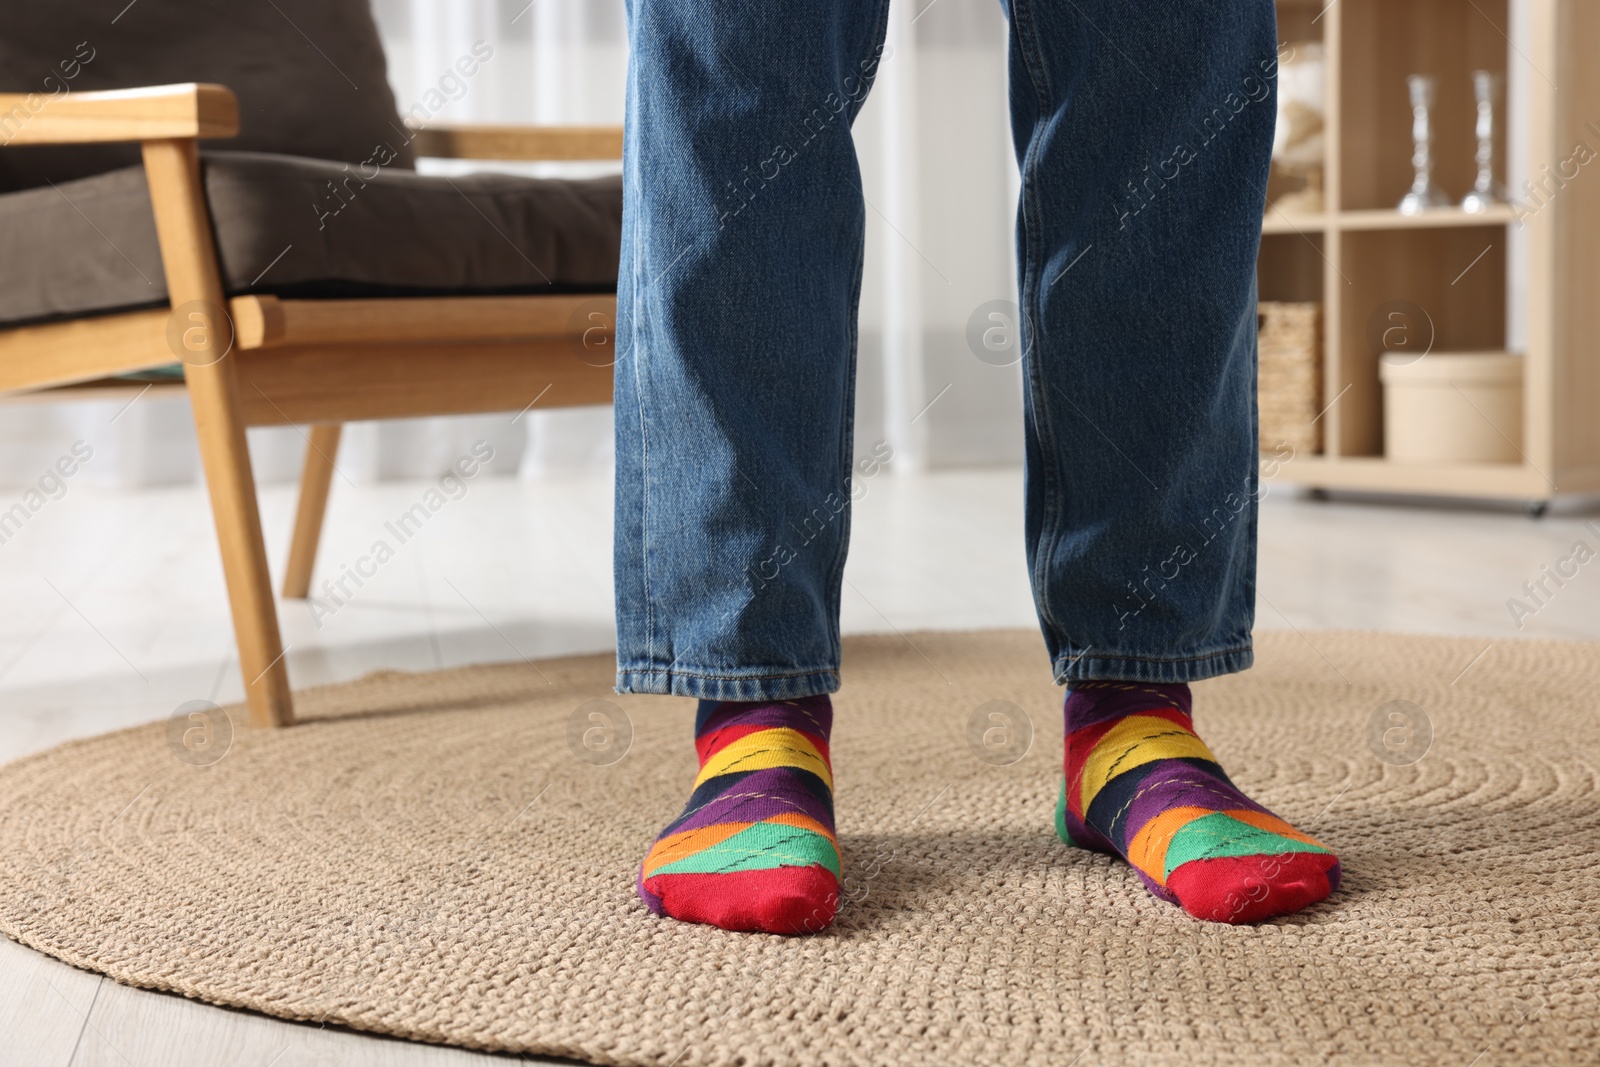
[614,0,888,701]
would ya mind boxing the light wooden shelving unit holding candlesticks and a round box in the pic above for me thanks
[1259,0,1600,502]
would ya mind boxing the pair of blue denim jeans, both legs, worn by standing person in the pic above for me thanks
[616,0,1278,701]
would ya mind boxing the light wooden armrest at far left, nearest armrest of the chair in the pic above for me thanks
[0,83,238,146]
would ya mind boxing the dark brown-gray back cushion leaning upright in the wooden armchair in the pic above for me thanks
[0,0,416,190]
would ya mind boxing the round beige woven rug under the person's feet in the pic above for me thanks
[0,632,1600,1067]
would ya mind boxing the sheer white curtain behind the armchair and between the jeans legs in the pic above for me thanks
[0,0,1021,488]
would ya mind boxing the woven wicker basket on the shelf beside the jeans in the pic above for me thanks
[1258,301,1322,456]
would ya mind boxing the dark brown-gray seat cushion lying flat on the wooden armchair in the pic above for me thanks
[0,152,622,325]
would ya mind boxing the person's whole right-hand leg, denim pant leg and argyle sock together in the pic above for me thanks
[1008,0,1339,921]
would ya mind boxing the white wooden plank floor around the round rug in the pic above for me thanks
[0,470,1600,1067]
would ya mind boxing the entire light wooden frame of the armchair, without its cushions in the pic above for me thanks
[0,85,622,726]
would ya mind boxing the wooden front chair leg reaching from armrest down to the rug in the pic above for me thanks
[144,141,294,726]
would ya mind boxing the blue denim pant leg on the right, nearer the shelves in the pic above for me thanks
[1006,0,1278,683]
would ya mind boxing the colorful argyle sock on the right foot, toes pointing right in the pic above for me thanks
[1056,681,1339,923]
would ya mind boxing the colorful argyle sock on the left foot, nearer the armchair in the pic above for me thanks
[638,696,840,934]
